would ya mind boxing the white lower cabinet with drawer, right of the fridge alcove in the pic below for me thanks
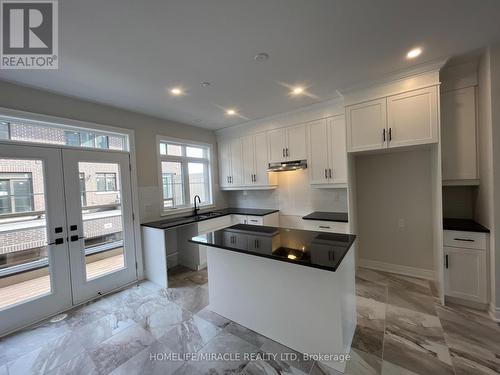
[444,231,488,304]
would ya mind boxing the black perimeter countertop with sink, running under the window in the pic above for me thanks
[141,207,279,229]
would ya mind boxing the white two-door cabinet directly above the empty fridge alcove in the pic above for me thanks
[346,86,439,152]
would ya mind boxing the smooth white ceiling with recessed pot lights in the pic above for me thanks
[0,0,500,129]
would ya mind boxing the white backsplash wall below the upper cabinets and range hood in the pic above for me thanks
[224,169,347,216]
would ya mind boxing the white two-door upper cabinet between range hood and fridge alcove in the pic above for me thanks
[307,116,347,185]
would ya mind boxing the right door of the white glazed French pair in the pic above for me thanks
[63,150,137,304]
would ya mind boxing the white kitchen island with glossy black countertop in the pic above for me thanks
[191,224,356,371]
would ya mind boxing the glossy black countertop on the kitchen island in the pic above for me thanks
[190,224,356,271]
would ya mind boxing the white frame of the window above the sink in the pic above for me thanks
[156,135,215,216]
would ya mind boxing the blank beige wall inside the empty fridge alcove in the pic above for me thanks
[356,149,434,271]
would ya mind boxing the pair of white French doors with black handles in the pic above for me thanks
[0,143,137,336]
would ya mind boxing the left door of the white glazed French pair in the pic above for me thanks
[0,145,71,334]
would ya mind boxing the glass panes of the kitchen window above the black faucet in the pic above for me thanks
[159,140,212,211]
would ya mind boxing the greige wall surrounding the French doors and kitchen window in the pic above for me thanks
[0,81,225,222]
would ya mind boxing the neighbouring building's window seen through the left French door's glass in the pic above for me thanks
[0,173,33,214]
